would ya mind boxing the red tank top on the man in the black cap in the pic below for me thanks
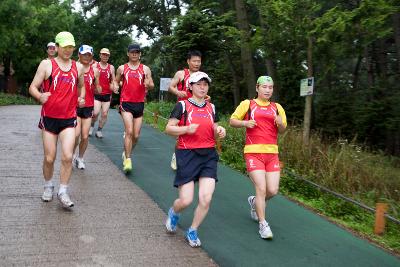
[120,64,146,103]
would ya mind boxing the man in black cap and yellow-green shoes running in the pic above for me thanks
[116,44,154,173]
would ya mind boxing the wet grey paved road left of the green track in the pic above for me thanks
[0,106,216,267]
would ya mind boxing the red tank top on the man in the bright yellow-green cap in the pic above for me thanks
[41,59,79,119]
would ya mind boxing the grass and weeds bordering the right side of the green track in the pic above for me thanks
[145,102,400,255]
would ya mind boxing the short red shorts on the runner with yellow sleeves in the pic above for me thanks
[244,153,281,172]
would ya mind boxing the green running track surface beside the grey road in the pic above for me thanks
[91,110,400,267]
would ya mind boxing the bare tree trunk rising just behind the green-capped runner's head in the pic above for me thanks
[235,0,256,98]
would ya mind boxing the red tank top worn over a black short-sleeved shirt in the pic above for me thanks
[177,100,215,149]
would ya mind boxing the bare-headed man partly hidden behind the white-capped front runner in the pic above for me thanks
[168,50,210,170]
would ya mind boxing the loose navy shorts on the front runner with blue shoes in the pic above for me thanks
[174,148,219,187]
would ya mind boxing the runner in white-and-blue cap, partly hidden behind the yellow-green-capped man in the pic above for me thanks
[73,45,101,170]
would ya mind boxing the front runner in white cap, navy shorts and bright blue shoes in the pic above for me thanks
[165,71,226,247]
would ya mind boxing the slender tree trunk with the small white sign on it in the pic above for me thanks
[303,37,313,145]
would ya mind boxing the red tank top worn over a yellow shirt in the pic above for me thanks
[246,100,278,145]
